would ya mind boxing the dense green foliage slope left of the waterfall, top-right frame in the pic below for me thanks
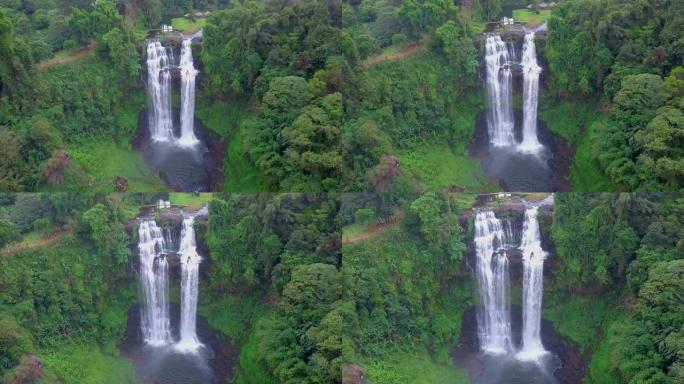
[342,0,482,192]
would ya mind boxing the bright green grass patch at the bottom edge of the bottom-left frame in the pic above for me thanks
[39,343,140,384]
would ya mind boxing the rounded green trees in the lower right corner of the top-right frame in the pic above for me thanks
[595,67,684,191]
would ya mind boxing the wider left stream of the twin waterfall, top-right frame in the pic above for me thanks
[485,35,515,146]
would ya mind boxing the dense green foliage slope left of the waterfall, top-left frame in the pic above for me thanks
[0,0,147,191]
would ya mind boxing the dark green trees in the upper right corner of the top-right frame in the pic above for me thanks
[546,0,684,99]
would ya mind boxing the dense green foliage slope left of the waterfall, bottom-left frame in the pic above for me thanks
[0,194,136,383]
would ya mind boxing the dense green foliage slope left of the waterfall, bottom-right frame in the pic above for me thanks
[342,193,472,383]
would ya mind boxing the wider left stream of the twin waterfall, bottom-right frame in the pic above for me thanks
[474,211,513,354]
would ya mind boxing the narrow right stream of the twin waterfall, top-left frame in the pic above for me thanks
[178,39,198,146]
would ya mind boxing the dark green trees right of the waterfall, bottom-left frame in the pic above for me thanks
[206,194,346,384]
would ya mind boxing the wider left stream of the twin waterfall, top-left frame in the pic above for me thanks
[147,41,174,141]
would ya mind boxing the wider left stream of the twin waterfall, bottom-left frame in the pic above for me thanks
[138,220,171,346]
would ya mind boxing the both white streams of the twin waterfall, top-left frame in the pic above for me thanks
[147,38,199,147]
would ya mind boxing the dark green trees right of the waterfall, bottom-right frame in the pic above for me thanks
[552,193,684,384]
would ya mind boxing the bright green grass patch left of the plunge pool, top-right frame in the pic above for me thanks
[399,143,495,192]
